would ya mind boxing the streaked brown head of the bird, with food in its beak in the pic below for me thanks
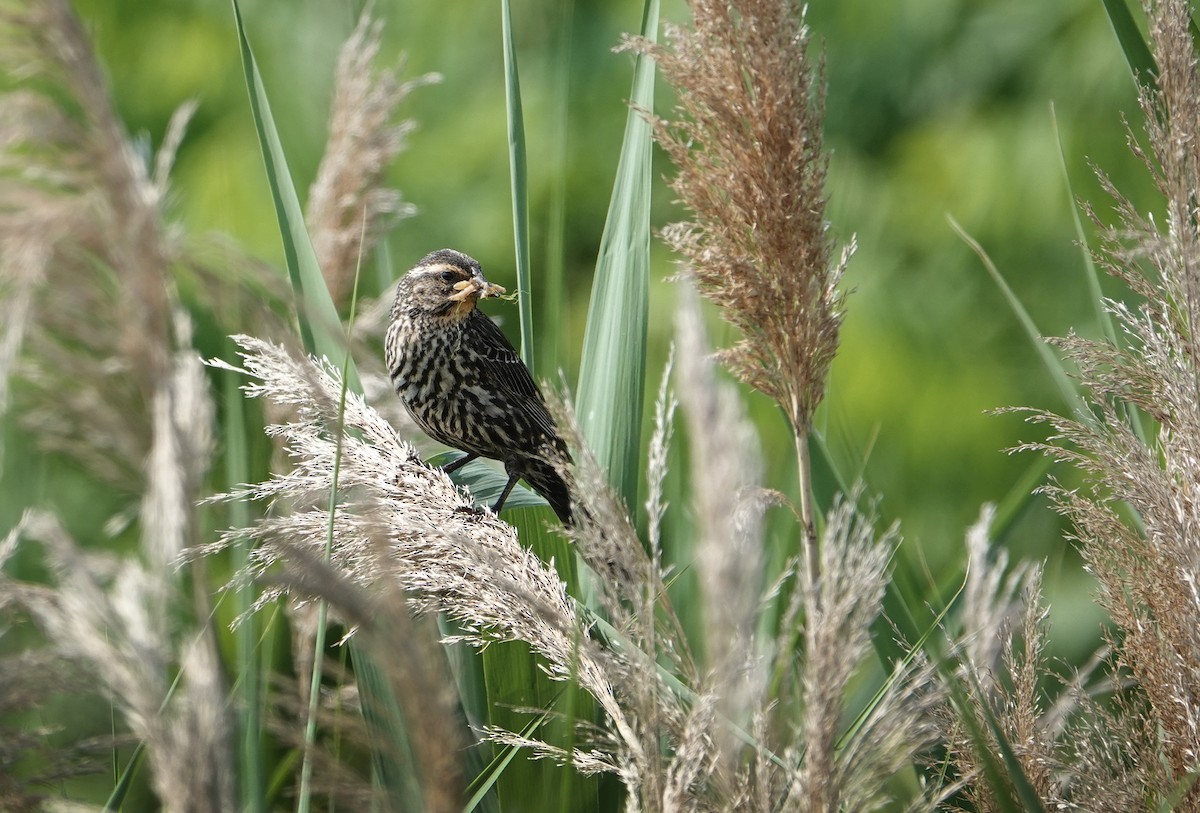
[394,248,504,320]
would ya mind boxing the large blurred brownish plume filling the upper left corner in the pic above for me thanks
[0,0,174,484]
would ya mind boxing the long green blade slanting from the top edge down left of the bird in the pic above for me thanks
[233,0,362,392]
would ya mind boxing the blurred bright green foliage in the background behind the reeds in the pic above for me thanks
[60,0,1150,658]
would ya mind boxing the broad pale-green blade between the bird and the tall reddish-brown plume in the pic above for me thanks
[575,0,659,508]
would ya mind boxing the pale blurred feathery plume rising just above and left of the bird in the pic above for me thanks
[305,5,442,302]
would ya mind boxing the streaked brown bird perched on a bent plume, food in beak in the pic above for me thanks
[385,248,571,525]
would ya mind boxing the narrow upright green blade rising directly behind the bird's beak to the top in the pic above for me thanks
[500,0,535,371]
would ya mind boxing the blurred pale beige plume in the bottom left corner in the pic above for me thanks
[0,514,234,813]
